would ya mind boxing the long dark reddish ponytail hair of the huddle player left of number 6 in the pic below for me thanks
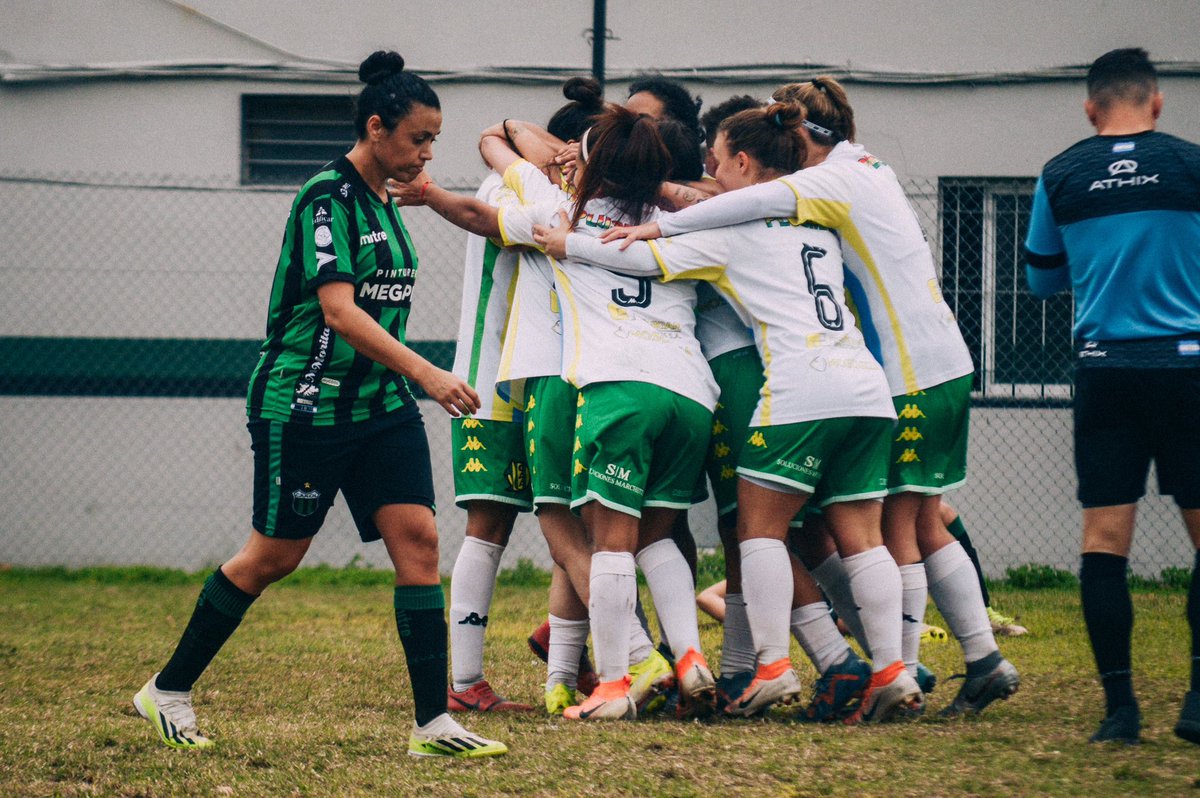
[571,106,671,224]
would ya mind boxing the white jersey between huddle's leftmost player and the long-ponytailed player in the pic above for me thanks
[497,160,571,402]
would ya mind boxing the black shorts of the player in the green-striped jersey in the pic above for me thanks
[246,402,434,542]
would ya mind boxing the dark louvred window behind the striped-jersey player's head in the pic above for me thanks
[241,95,355,186]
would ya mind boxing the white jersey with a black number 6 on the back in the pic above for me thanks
[568,218,895,426]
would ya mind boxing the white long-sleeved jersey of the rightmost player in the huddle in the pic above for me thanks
[659,142,973,396]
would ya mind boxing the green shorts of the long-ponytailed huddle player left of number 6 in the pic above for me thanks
[571,382,713,517]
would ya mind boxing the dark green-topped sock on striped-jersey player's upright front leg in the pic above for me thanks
[394,584,446,726]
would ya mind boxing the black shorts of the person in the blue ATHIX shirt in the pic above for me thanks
[1075,367,1200,510]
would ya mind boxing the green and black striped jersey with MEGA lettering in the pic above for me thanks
[246,156,427,426]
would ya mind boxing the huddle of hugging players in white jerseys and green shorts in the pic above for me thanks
[408,69,1020,724]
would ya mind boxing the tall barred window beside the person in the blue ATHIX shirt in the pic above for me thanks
[938,178,1074,400]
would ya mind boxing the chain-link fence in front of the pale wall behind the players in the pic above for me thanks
[0,174,1190,576]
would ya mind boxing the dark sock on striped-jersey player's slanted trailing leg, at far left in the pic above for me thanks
[155,568,258,691]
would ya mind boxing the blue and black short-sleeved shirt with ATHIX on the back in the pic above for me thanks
[1025,131,1200,341]
